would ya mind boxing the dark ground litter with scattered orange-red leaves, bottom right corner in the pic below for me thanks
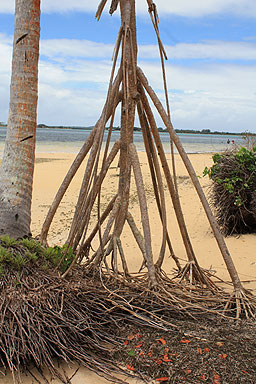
[119,317,256,384]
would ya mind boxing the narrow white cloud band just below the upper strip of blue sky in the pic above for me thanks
[40,39,256,61]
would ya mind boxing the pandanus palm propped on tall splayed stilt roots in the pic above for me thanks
[41,0,255,317]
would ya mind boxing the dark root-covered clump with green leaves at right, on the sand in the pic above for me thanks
[204,147,256,235]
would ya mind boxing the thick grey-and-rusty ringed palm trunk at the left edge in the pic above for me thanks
[0,0,40,238]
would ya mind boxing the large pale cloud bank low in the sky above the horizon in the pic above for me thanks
[39,61,256,132]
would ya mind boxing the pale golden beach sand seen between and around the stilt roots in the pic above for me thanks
[0,152,256,384]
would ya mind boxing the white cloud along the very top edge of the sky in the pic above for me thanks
[0,0,256,17]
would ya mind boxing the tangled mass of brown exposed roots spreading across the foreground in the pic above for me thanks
[0,252,255,383]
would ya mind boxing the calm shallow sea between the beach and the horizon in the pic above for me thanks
[0,127,244,155]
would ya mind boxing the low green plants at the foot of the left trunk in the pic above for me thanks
[0,236,75,276]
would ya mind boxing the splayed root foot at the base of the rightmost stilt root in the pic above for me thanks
[223,287,256,320]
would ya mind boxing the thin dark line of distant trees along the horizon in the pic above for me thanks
[0,122,256,136]
